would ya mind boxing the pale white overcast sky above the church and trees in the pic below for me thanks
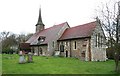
[0,0,114,34]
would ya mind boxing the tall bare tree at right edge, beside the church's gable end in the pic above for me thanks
[95,1,120,72]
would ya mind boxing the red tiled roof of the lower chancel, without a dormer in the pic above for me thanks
[59,21,96,40]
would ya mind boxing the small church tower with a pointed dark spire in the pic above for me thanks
[35,8,45,32]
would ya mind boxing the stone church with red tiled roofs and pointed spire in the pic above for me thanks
[26,9,106,61]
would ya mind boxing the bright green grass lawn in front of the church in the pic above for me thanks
[2,54,115,74]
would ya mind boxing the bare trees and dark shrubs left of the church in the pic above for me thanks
[0,31,33,53]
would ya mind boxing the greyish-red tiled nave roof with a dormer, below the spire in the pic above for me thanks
[26,22,67,45]
